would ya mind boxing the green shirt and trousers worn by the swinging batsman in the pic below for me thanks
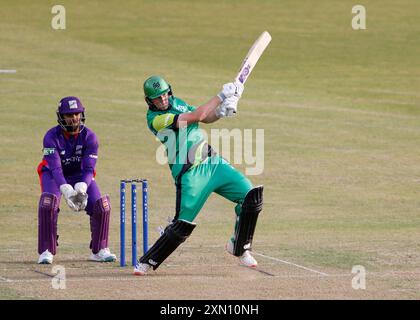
[147,96,252,222]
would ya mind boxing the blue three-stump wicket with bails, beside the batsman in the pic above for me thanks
[120,179,149,267]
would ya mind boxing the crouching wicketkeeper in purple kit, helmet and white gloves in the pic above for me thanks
[38,97,116,264]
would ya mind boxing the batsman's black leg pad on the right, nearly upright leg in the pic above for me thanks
[233,186,264,257]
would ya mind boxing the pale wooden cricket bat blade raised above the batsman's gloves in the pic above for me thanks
[235,31,271,84]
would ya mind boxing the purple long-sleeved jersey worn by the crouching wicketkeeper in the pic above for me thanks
[38,126,98,186]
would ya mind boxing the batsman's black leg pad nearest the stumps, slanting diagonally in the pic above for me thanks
[139,220,196,270]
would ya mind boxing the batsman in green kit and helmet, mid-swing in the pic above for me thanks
[134,76,263,275]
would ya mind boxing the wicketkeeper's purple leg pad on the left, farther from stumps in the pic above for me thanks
[38,192,59,255]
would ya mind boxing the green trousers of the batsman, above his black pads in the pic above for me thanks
[176,155,252,222]
